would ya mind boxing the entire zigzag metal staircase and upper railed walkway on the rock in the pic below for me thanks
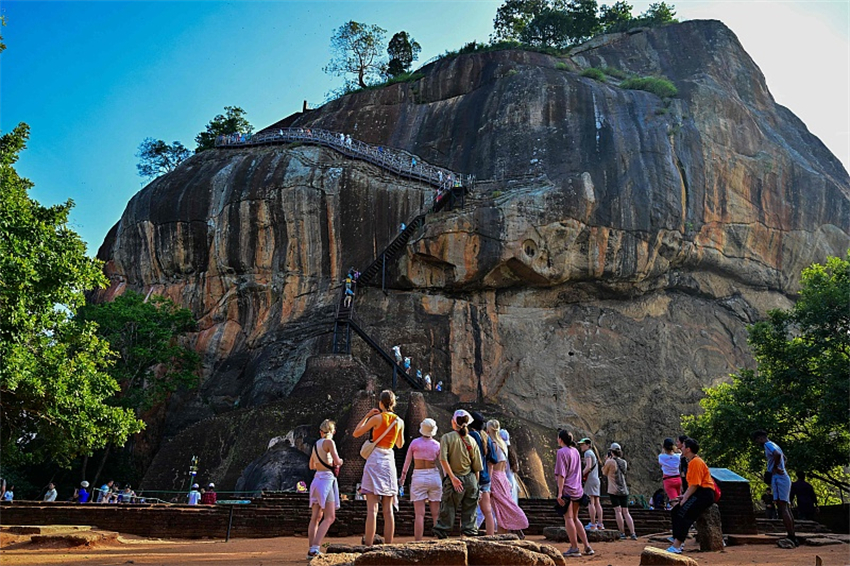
[215,128,475,389]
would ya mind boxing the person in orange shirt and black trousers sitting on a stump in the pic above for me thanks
[667,438,714,554]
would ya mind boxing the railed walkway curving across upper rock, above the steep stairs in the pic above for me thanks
[215,128,474,192]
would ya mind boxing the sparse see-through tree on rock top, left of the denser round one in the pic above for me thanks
[324,21,387,88]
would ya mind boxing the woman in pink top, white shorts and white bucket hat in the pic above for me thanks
[400,419,443,540]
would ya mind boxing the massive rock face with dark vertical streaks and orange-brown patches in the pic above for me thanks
[98,21,850,493]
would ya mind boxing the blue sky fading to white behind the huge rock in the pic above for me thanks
[0,0,850,255]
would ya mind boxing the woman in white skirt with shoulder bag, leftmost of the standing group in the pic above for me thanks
[307,419,342,558]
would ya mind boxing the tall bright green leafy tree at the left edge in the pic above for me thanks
[0,123,143,465]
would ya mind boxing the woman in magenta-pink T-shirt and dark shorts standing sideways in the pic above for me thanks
[555,430,594,558]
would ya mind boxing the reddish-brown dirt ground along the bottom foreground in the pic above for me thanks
[0,535,850,566]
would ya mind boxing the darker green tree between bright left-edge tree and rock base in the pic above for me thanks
[77,291,200,414]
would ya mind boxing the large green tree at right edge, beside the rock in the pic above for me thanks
[683,252,850,489]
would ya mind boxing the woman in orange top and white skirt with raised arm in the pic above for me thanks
[351,389,404,546]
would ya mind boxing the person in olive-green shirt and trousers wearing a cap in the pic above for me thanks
[434,409,483,539]
